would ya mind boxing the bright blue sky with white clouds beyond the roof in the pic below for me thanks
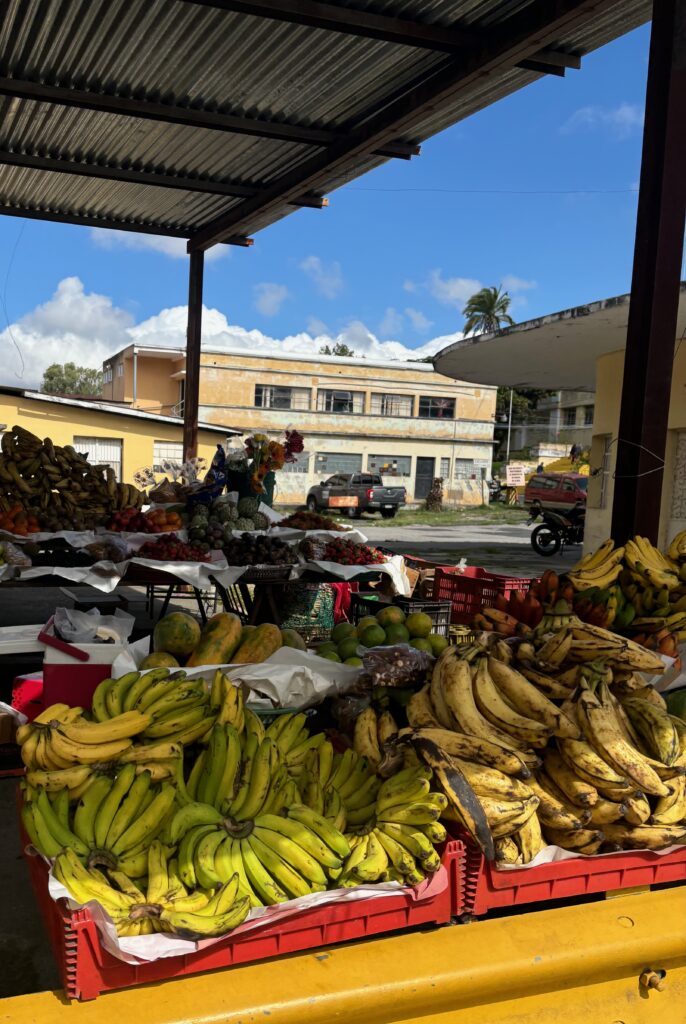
[0,26,649,383]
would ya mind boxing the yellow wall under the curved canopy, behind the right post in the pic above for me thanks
[585,345,686,551]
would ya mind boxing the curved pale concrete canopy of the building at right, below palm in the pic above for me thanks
[433,282,686,391]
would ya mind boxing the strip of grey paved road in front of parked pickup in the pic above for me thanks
[364,519,582,577]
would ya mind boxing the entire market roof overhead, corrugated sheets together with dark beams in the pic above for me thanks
[0,0,651,250]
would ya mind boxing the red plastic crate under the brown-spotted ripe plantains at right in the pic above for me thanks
[454,839,686,916]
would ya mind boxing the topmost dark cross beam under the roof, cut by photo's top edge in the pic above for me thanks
[183,0,581,69]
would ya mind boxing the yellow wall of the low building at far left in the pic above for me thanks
[0,393,224,483]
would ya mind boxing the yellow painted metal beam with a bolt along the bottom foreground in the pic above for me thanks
[0,888,686,1024]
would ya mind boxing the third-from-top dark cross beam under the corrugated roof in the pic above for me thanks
[0,150,328,209]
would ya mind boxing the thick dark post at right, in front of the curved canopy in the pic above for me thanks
[612,0,686,544]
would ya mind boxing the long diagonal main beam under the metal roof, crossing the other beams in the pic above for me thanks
[188,0,599,250]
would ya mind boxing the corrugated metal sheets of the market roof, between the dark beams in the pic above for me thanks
[0,0,651,242]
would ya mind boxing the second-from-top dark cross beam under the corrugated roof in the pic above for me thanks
[0,77,419,160]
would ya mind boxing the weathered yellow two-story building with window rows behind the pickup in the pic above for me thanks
[103,345,496,504]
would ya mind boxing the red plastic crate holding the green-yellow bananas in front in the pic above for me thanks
[26,840,465,999]
